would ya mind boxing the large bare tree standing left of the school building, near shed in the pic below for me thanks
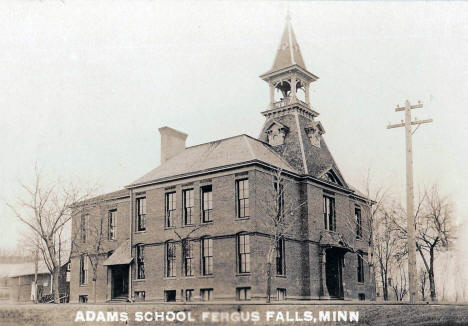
[8,167,92,303]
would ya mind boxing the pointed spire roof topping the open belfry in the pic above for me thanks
[270,15,306,71]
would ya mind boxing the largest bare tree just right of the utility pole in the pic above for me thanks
[395,185,454,301]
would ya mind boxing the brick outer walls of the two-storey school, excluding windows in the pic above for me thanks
[71,166,372,302]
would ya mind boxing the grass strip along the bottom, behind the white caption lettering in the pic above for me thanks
[0,302,468,326]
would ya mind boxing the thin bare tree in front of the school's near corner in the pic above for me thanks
[259,167,306,303]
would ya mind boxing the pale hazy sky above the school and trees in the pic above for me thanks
[0,0,468,288]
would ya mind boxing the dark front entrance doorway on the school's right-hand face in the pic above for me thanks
[325,249,343,298]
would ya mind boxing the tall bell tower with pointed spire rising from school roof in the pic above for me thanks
[259,15,346,186]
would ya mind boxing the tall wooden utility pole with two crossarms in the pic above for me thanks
[387,100,433,303]
